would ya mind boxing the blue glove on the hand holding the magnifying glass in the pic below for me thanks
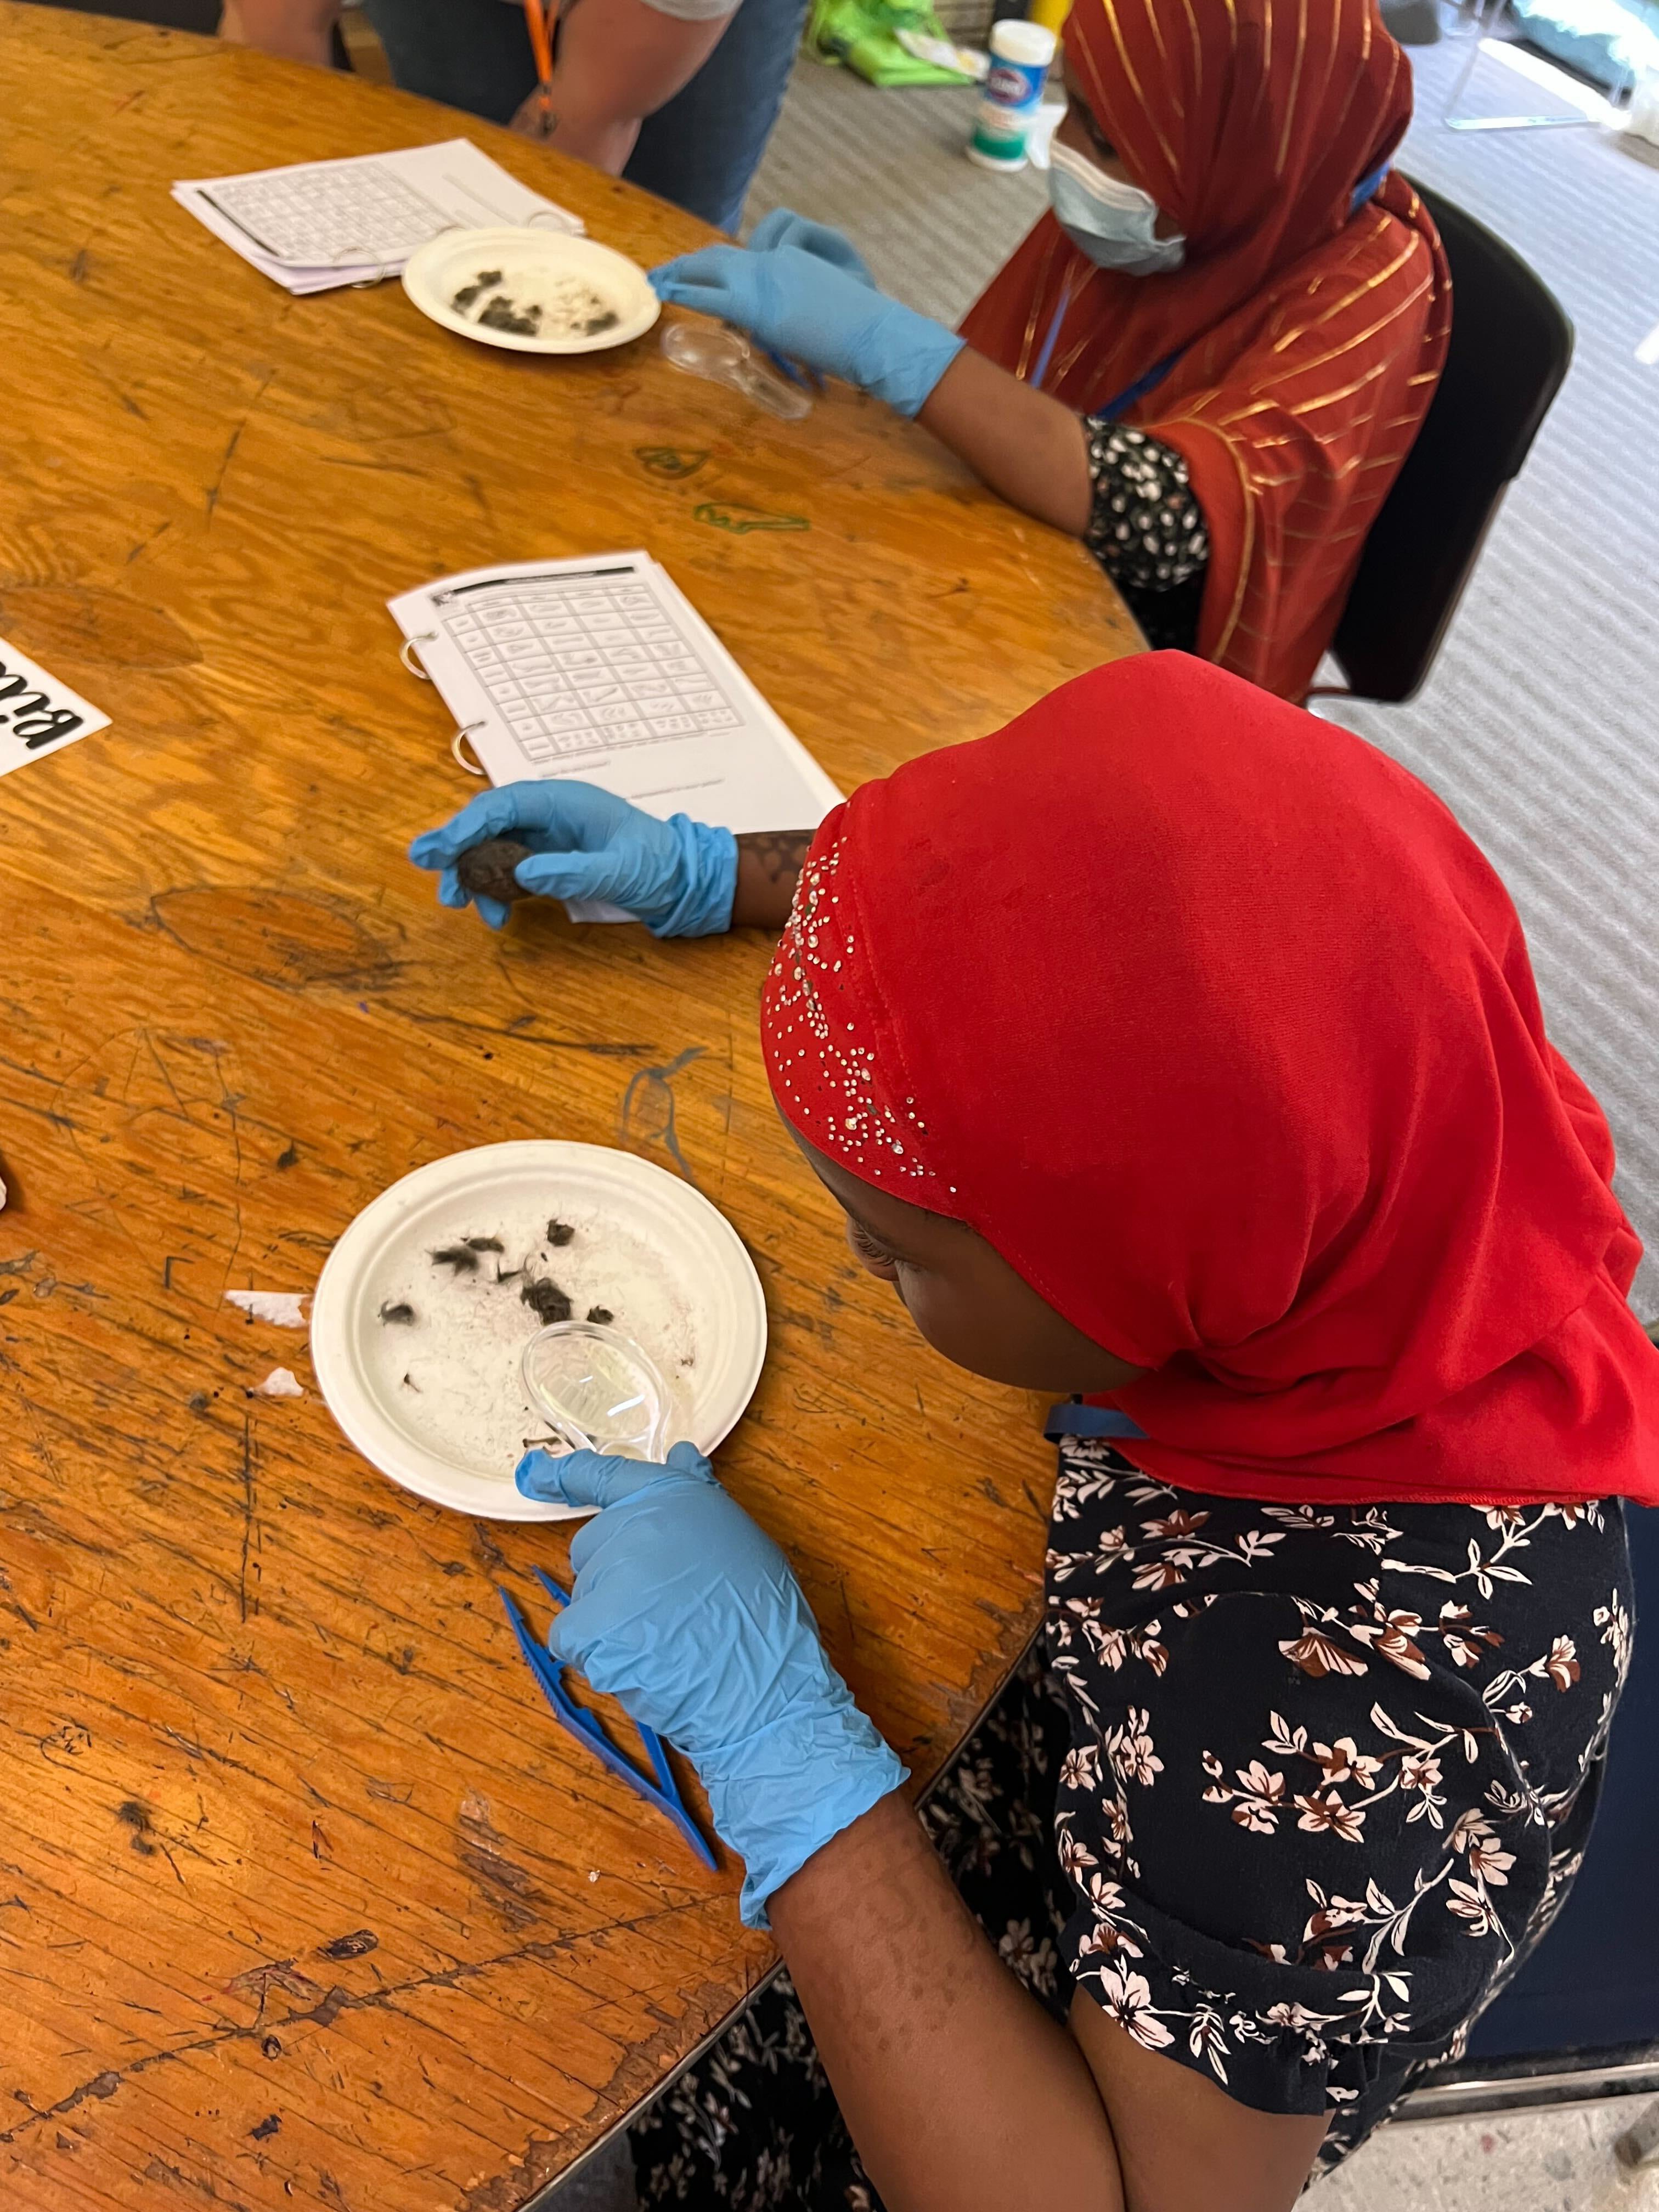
[515,1444,905,1929]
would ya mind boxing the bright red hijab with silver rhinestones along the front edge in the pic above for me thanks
[763,652,1659,1504]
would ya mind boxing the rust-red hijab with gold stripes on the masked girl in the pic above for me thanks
[962,0,1451,699]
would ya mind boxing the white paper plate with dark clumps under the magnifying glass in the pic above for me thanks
[312,1139,765,1520]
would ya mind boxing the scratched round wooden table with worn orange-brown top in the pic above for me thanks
[0,21,1137,2212]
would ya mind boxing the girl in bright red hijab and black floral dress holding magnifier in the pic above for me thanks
[414,652,1659,2212]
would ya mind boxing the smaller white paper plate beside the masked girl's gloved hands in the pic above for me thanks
[403,228,662,354]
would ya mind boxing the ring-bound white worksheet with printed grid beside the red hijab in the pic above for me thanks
[390,553,840,832]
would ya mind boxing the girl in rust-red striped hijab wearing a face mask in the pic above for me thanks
[652,0,1451,699]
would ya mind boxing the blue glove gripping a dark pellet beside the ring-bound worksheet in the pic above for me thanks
[409,783,737,938]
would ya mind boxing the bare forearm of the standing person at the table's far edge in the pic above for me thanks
[513,0,730,161]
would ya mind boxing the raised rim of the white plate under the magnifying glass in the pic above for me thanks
[307,1137,770,1522]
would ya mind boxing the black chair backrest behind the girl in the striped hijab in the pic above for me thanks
[1331,184,1573,701]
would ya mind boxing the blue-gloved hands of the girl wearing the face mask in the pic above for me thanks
[650,208,962,416]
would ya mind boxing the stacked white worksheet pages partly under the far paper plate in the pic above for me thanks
[172,139,582,292]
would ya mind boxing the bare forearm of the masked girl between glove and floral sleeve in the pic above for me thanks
[918,345,1093,538]
